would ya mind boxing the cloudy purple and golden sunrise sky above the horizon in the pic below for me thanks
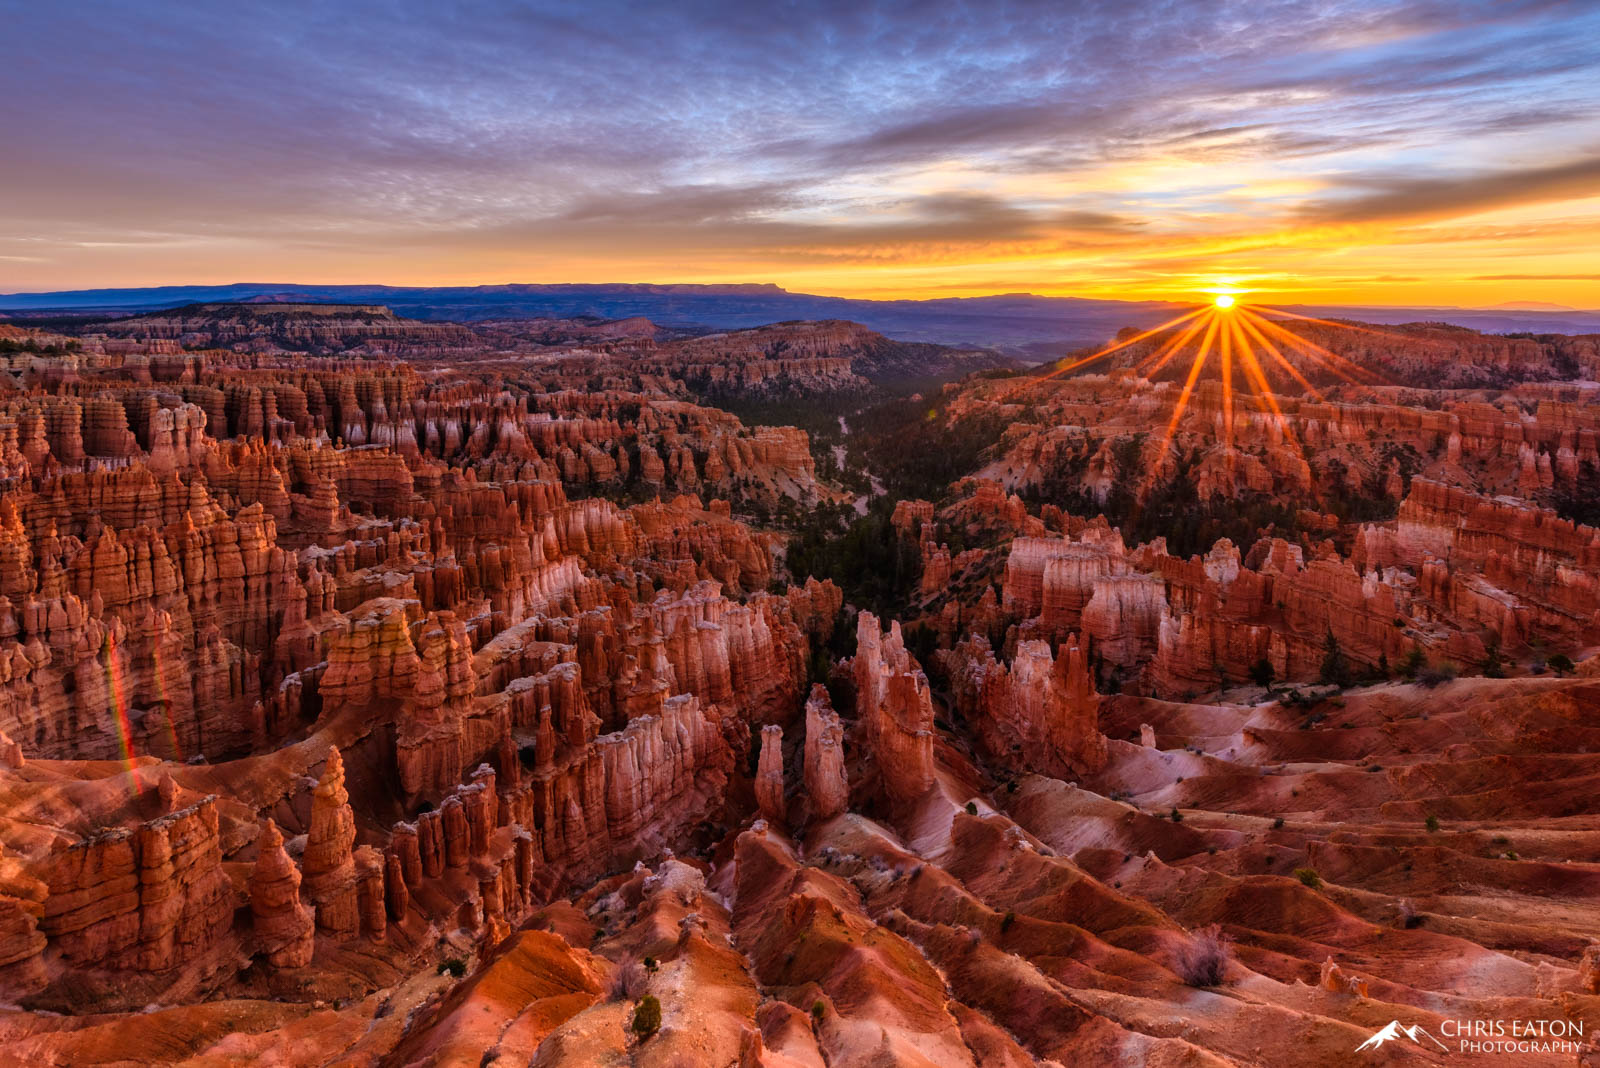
[0,0,1600,309]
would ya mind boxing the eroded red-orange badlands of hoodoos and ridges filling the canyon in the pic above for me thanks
[0,301,1600,1068]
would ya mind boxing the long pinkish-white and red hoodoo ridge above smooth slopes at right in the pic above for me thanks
[992,480,1597,695]
